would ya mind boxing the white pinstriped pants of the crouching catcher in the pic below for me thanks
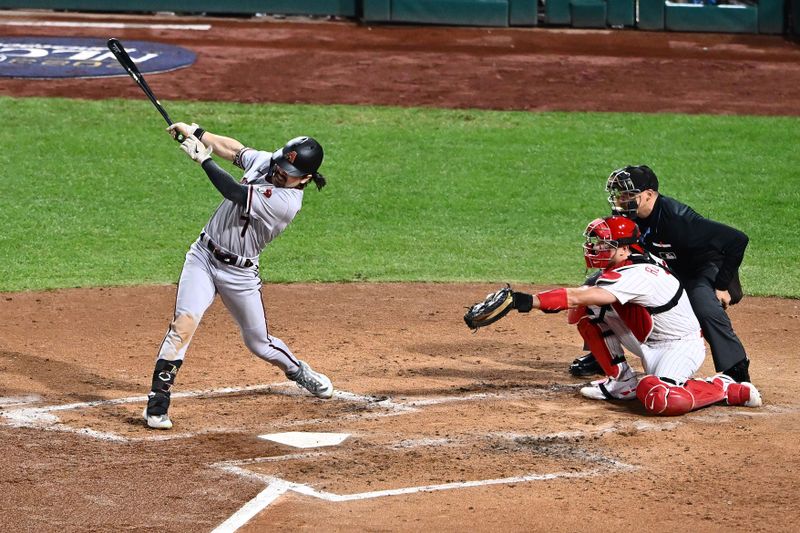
[592,304,706,384]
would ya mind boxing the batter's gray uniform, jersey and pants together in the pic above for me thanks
[158,145,303,372]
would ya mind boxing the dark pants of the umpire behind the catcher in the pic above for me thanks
[681,263,747,372]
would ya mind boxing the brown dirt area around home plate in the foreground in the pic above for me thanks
[0,284,800,531]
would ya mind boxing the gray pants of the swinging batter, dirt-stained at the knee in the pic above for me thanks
[158,241,299,372]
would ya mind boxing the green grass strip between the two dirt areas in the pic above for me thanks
[0,98,800,297]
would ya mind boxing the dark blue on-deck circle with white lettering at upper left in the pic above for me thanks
[0,37,196,78]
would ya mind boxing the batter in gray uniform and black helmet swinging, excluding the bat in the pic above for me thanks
[144,122,333,429]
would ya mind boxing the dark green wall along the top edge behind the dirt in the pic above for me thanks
[0,0,800,34]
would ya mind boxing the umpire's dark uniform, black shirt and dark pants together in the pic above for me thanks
[636,195,750,382]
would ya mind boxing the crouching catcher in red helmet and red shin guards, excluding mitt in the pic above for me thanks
[514,216,761,415]
